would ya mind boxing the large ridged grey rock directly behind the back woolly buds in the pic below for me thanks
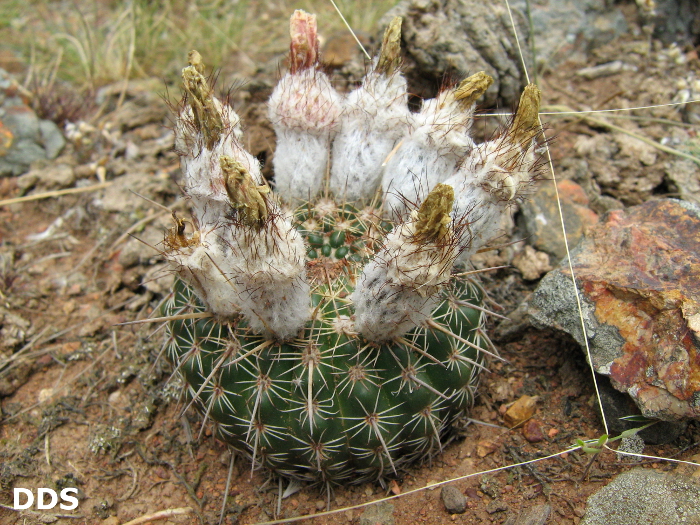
[380,0,529,107]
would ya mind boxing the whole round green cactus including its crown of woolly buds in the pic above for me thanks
[163,11,540,486]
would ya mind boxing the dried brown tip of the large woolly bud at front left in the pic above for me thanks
[219,155,270,227]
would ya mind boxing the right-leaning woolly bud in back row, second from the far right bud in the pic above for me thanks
[382,72,493,215]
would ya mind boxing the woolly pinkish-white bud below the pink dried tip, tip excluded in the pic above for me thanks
[268,68,343,203]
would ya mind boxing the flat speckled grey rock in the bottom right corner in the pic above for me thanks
[581,468,700,525]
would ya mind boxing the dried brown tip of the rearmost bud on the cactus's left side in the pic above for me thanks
[182,51,224,149]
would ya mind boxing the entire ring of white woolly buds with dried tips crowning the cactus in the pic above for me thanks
[166,11,540,341]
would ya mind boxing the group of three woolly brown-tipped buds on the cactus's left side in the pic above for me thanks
[165,51,310,339]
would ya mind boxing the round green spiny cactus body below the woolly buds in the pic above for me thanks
[163,206,483,483]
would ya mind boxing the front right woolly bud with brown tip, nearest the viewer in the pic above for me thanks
[352,184,458,341]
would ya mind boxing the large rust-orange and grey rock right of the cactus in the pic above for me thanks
[528,199,700,421]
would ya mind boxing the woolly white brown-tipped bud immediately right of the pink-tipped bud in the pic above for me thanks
[330,17,412,201]
